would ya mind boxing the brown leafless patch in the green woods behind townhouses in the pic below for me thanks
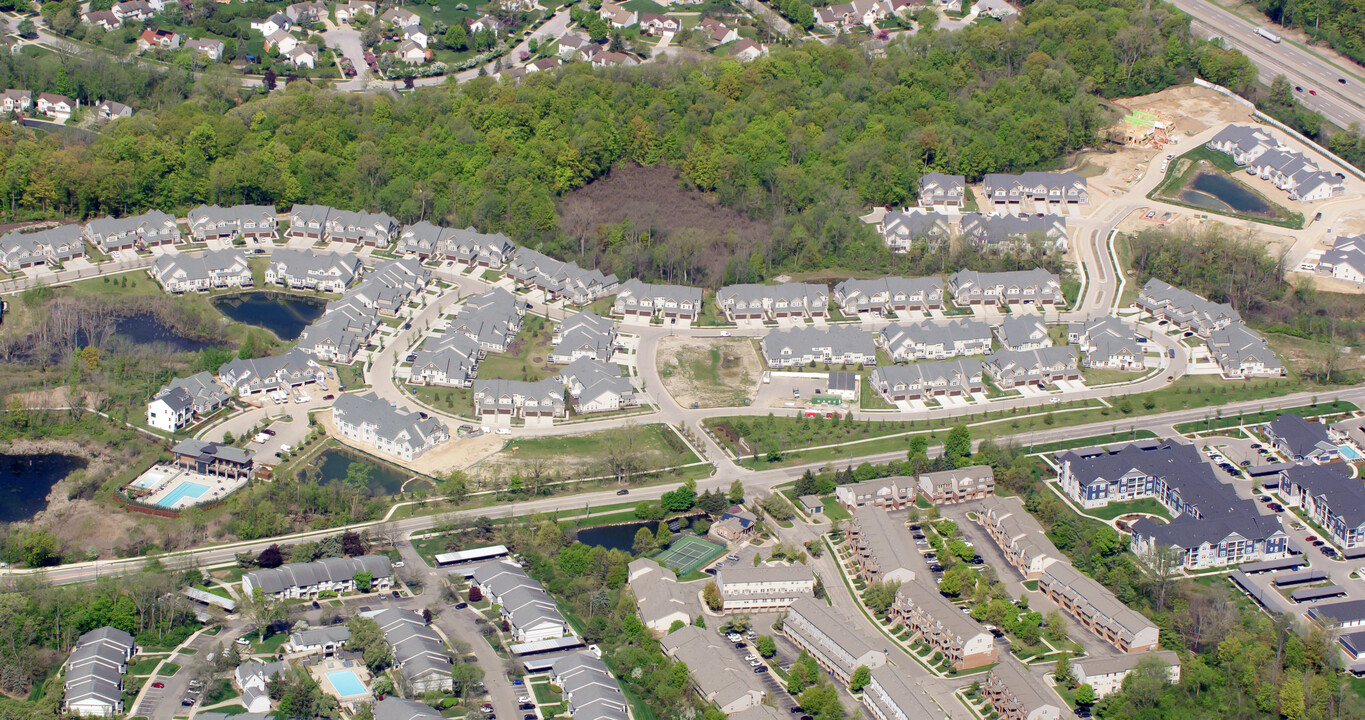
[560,164,771,286]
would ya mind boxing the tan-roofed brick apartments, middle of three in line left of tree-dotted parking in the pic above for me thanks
[891,578,999,671]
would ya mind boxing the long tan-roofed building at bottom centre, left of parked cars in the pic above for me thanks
[659,626,767,715]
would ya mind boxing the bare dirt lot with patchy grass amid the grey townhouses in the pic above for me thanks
[659,337,763,407]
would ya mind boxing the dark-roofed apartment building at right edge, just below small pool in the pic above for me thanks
[1279,463,1365,549]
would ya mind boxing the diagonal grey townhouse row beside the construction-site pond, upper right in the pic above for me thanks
[1208,126,1346,202]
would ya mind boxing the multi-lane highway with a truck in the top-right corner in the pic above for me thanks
[1179,0,1365,127]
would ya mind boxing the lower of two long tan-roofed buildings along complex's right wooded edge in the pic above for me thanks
[1037,563,1158,653]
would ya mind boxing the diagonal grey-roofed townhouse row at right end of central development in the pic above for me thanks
[1134,277,1284,377]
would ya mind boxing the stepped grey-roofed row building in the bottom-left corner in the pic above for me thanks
[61,626,138,717]
